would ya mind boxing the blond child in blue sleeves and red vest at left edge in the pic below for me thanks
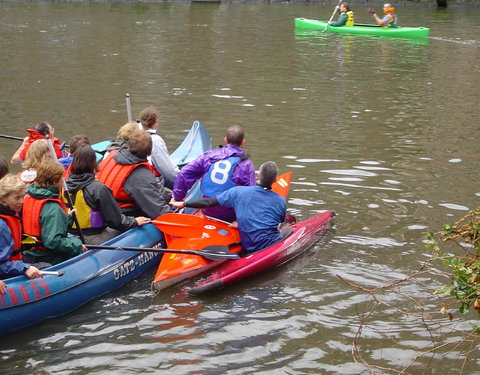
[0,174,42,280]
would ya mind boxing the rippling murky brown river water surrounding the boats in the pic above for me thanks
[0,2,480,375]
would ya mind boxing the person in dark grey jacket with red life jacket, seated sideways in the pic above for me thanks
[97,129,171,219]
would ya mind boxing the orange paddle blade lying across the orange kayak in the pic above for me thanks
[152,213,203,238]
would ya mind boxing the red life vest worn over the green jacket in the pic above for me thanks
[22,194,67,250]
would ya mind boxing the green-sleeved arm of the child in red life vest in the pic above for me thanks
[40,202,82,257]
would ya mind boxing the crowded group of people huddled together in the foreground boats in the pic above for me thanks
[0,107,286,293]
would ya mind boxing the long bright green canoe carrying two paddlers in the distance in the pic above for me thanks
[295,18,430,38]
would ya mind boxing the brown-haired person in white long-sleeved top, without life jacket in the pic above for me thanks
[140,107,179,189]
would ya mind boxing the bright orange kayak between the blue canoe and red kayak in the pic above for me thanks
[152,172,292,292]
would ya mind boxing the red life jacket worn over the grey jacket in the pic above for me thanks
[97,150,153,208]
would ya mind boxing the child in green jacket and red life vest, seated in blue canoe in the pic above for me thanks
[22,161,87,264]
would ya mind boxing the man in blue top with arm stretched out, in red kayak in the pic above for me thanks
[170,161,287,252]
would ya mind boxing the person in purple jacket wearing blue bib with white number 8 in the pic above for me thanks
[173,125,256,222]
